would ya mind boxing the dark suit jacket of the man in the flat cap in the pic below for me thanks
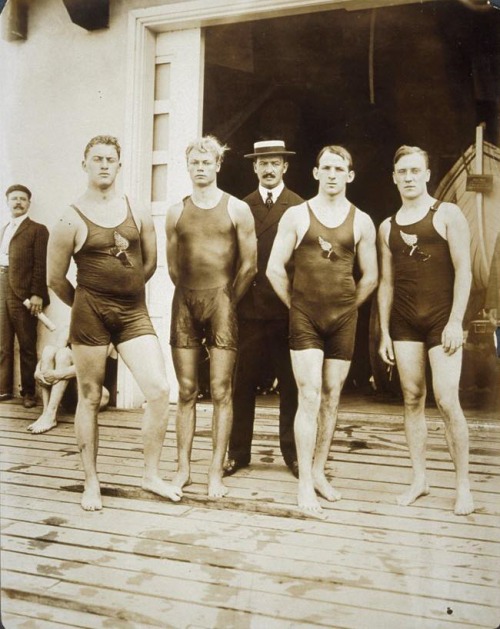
[0,218,49,307]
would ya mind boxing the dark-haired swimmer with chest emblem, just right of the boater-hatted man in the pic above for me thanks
[267,145,378,515]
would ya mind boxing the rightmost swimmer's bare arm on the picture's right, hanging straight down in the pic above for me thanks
[442,203,472,354]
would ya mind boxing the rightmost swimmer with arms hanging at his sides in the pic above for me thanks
[378,146,474,515]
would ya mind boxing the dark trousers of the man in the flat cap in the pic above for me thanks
[0,267,38,395]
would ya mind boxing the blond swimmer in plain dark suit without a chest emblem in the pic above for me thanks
[166,136,257,498]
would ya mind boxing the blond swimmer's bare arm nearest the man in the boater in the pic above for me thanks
[227,197,257,302]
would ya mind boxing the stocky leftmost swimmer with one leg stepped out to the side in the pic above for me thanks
[48,135,182,511]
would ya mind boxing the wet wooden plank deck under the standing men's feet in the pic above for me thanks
[0,400,500,629]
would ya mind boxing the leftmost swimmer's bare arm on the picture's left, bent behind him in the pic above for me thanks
[47,208,82,307]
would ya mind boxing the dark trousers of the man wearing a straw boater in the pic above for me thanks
[229,319,297,464]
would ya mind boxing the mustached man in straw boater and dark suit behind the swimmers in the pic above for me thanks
[224,140,303,477]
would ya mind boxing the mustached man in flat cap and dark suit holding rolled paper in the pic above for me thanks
[0,184,49,408]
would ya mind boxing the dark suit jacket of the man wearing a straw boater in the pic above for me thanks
[238,187,303,319]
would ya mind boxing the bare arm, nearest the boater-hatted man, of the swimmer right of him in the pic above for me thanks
[266,206,302,308]
